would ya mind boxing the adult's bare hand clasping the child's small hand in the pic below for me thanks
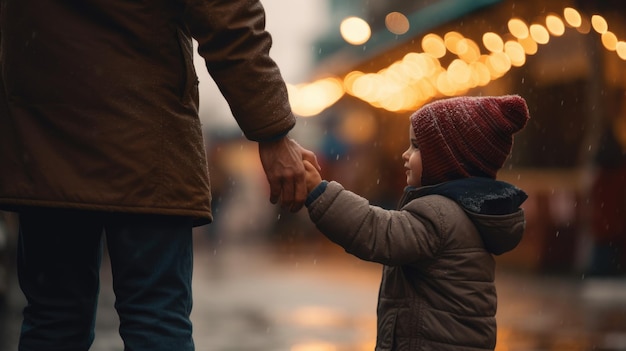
[259,137,320,212]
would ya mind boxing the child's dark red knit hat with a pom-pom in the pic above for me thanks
[411,95,530,185]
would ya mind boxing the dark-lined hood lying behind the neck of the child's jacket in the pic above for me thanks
[400,177,528,255]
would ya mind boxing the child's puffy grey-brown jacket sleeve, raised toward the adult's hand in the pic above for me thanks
[308,182,445,266]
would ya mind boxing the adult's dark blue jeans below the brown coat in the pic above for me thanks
[17,209,194,351]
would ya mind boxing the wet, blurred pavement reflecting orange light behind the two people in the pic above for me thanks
[0,236,626,351]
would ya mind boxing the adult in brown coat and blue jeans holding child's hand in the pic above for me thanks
[0,0,315,350]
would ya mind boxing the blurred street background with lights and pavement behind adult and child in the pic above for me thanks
[0,0,626,351]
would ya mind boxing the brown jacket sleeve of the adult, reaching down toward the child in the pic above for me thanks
[179,0,295,141]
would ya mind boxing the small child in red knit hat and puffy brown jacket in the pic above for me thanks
[305,95,529,351]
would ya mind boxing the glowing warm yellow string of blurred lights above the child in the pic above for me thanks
[288,7,626,117]
